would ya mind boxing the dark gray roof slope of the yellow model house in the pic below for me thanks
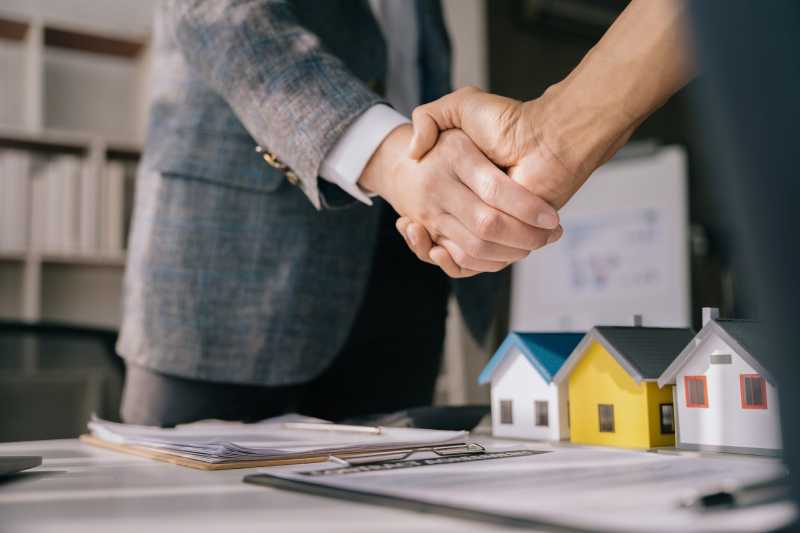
[595,326,694,379]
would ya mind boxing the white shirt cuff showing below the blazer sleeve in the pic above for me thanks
[319,104,410,205]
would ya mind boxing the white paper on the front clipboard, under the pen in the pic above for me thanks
[264,446,796,532]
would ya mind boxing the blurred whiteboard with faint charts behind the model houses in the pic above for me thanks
[511,146,691,331]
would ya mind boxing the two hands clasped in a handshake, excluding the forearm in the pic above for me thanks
[359,85,628,277]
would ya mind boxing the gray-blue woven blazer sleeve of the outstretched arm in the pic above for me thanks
[165,0,381,209]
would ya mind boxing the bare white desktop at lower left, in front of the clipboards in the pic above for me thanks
[0,439,518,533]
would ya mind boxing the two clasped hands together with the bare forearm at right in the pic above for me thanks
[359,0,694,277]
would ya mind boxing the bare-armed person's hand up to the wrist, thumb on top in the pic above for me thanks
[409,85,629,208]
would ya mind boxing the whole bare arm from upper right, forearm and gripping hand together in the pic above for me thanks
[398,0,694,274]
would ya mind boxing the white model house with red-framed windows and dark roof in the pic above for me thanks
[658,308,781,454]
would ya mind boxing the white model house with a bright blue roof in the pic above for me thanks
[478,332,583,440]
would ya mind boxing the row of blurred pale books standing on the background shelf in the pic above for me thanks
[0,150,136,256]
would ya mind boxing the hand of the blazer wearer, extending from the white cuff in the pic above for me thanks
[359,125,559,277]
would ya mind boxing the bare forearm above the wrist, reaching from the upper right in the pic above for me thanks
[539,0,694,176]
